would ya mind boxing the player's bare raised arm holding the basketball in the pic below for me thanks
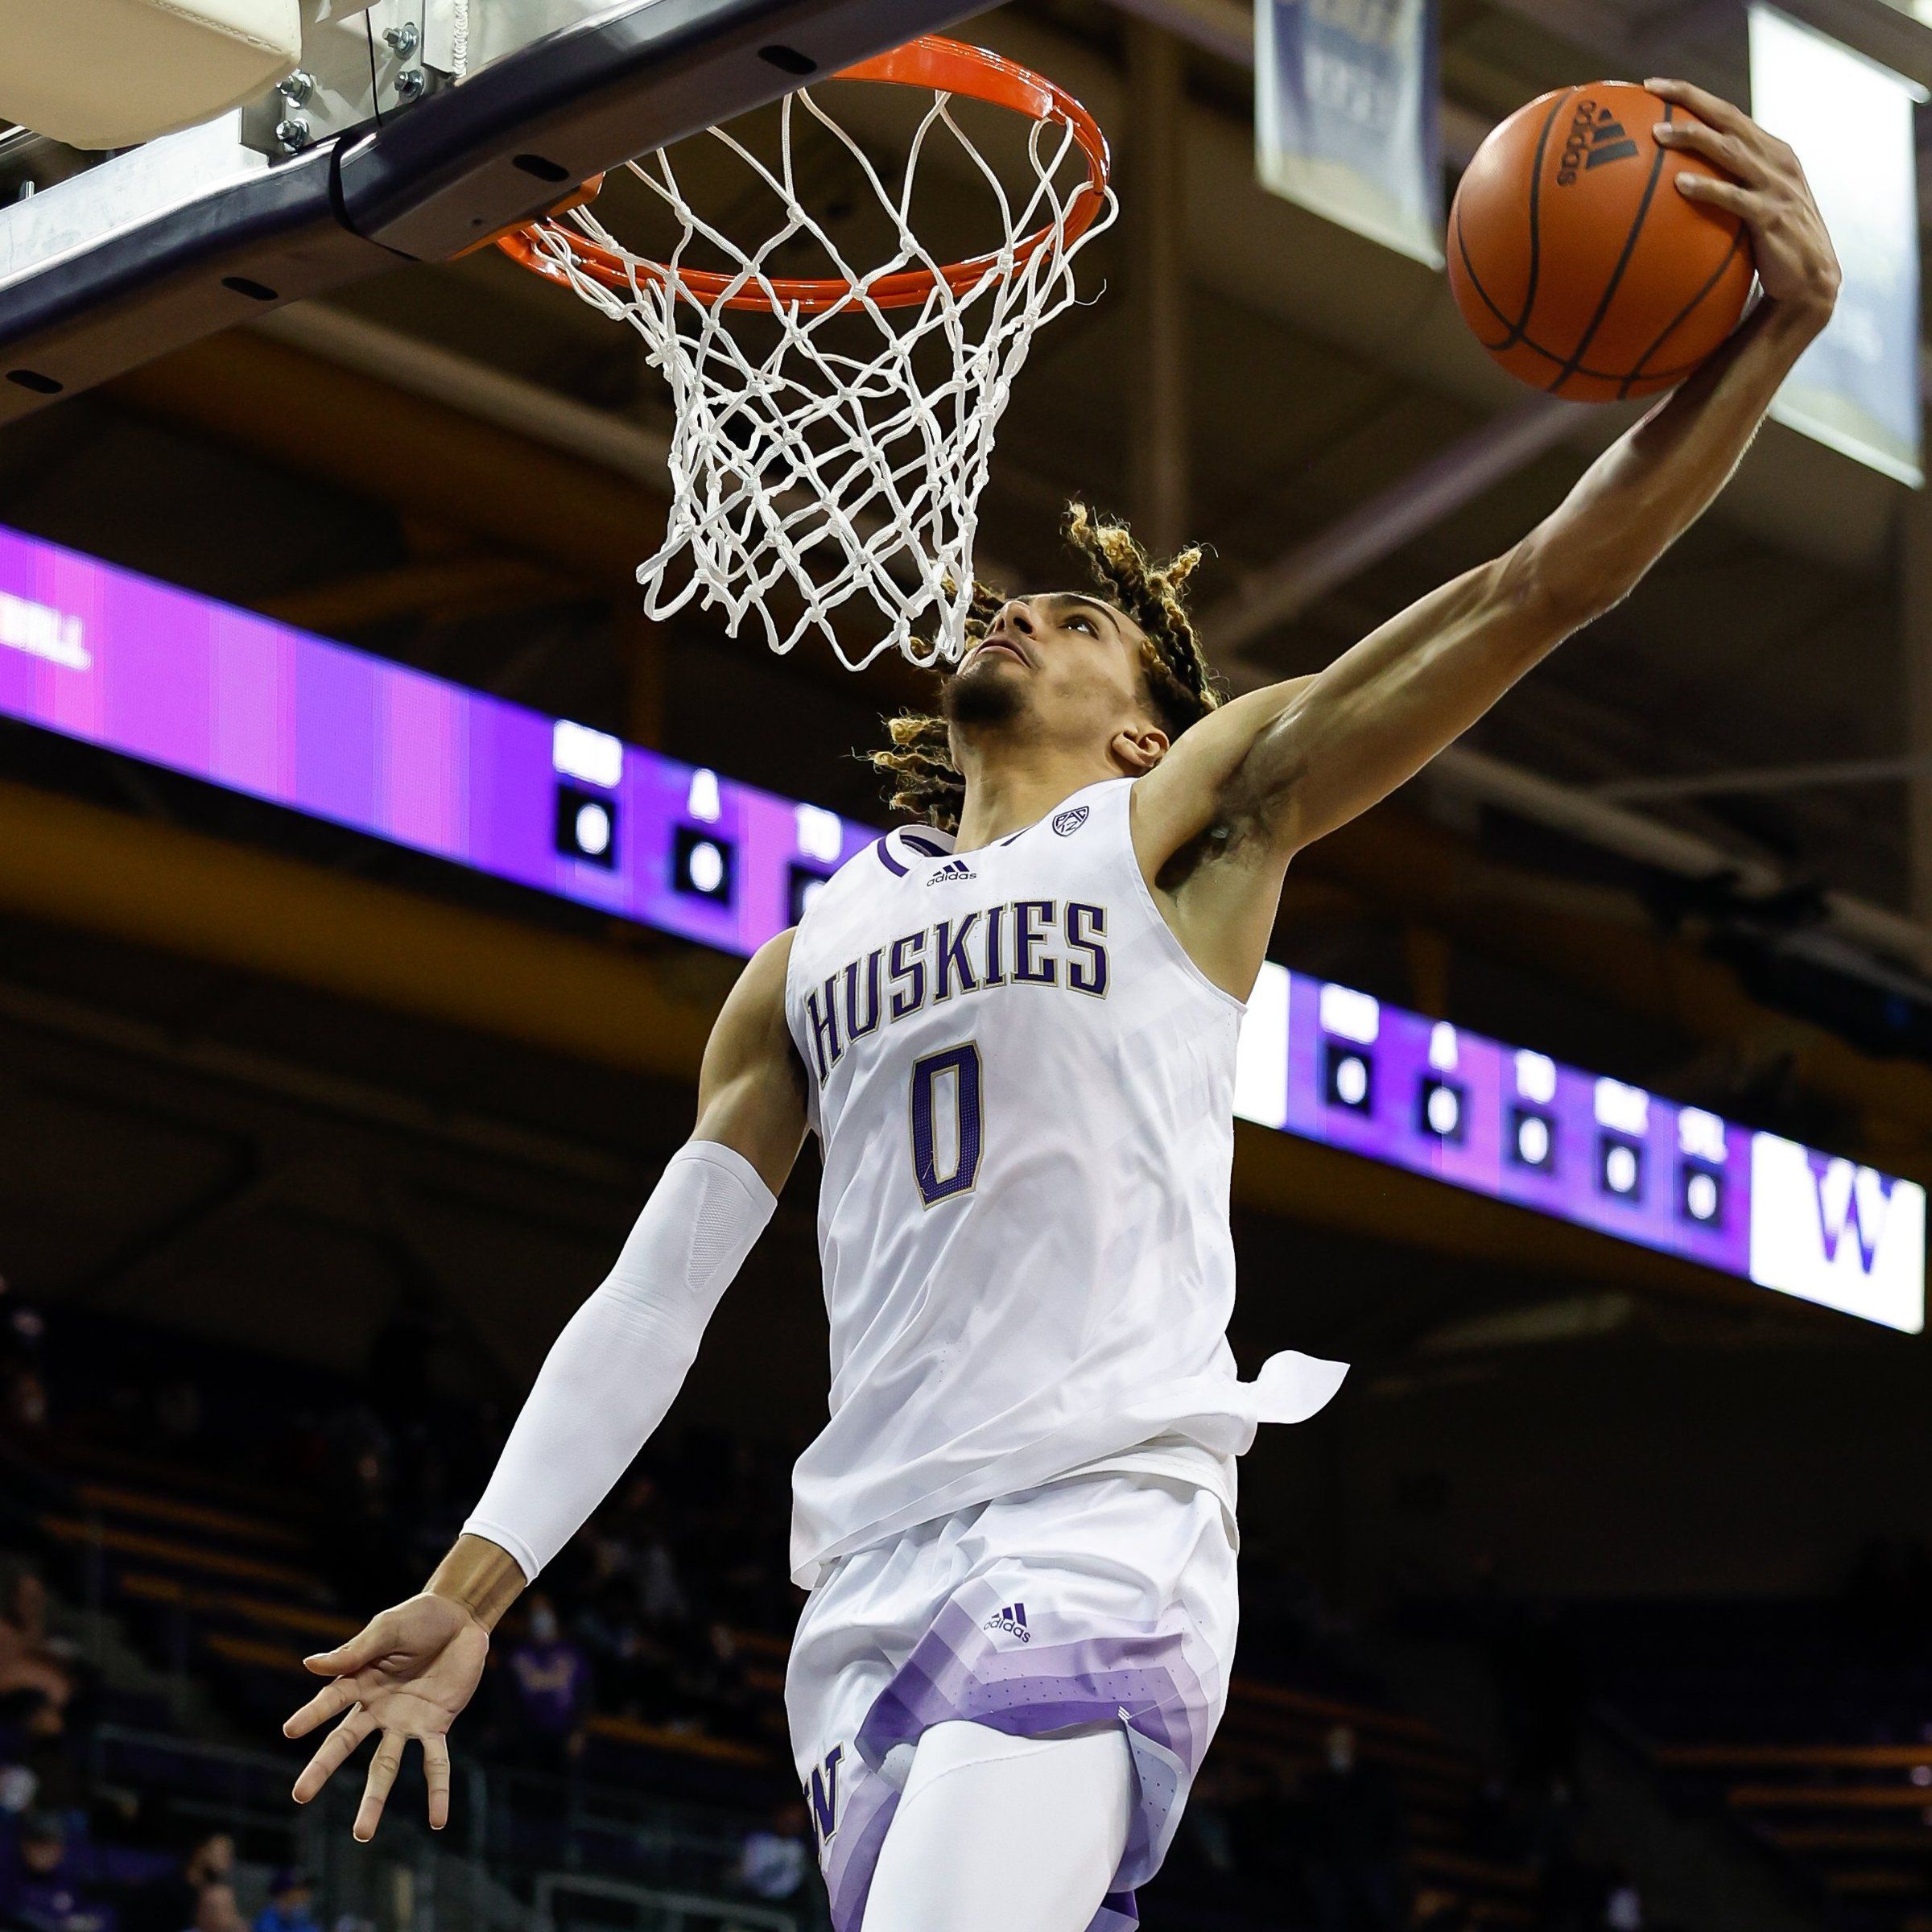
[1136,81,1839,991]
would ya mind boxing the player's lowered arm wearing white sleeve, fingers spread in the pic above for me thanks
[282,933,806,1839]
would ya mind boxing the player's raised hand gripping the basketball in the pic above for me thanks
[1644,81,1839,324]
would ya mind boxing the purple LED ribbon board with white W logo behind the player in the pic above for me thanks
[0,530,1926,1333]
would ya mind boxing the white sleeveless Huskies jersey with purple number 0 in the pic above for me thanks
[784,778,1341,1586]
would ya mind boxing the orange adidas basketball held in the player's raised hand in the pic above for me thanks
[1449,81,1754,402]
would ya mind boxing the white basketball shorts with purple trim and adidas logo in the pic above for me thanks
[784,1474,1238,1932]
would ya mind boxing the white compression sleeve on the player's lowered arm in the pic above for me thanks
[464,1140,777,1583]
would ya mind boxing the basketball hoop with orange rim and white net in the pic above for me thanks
[498,35,1115,671]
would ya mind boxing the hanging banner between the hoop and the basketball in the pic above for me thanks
[1254,0,1443,269]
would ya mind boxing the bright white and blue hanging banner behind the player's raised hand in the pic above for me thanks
[1750,4,1926,487]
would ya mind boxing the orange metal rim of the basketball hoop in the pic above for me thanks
[497,33,1109,315]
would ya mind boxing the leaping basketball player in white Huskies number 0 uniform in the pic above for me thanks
[286,83,1837,1932]
